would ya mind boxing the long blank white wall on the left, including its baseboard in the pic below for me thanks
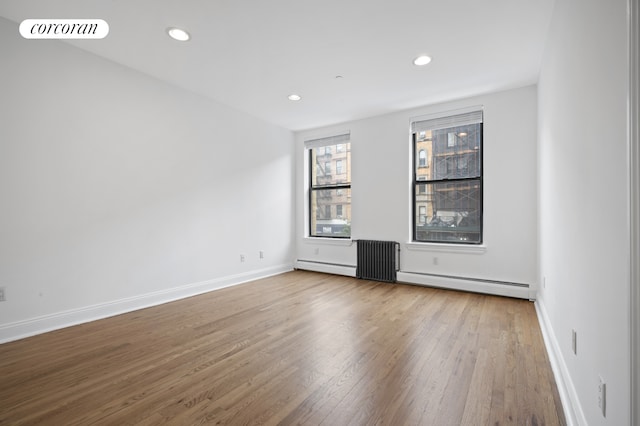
[0,19,294,341]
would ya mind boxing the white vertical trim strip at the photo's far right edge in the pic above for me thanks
[628,0,640,425]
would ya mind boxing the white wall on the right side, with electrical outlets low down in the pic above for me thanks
[538,0,637,426]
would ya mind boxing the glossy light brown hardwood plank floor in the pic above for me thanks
[0,271,565,426]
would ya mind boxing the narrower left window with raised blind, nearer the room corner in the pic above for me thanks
[305,134,351,238]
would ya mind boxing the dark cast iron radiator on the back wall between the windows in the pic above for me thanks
[356,240,400,283]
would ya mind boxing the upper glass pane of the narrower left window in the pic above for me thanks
[311,143,351,187]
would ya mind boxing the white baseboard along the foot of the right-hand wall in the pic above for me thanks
[535,300,588,426]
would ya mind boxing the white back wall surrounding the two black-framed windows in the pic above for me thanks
[296,86,537,297]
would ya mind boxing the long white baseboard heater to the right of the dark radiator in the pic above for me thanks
[397,272,535,299]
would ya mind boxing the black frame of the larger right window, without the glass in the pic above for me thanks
[411,108,485,246]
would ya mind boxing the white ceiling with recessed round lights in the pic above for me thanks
[0,0,555,130]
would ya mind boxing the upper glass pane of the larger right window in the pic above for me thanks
[415,124,482,180]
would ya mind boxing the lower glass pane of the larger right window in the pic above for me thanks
[414,181,482,243]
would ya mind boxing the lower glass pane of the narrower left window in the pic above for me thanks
[310,188,351,237]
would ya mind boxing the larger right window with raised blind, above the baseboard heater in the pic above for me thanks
[411,110,483,244]
